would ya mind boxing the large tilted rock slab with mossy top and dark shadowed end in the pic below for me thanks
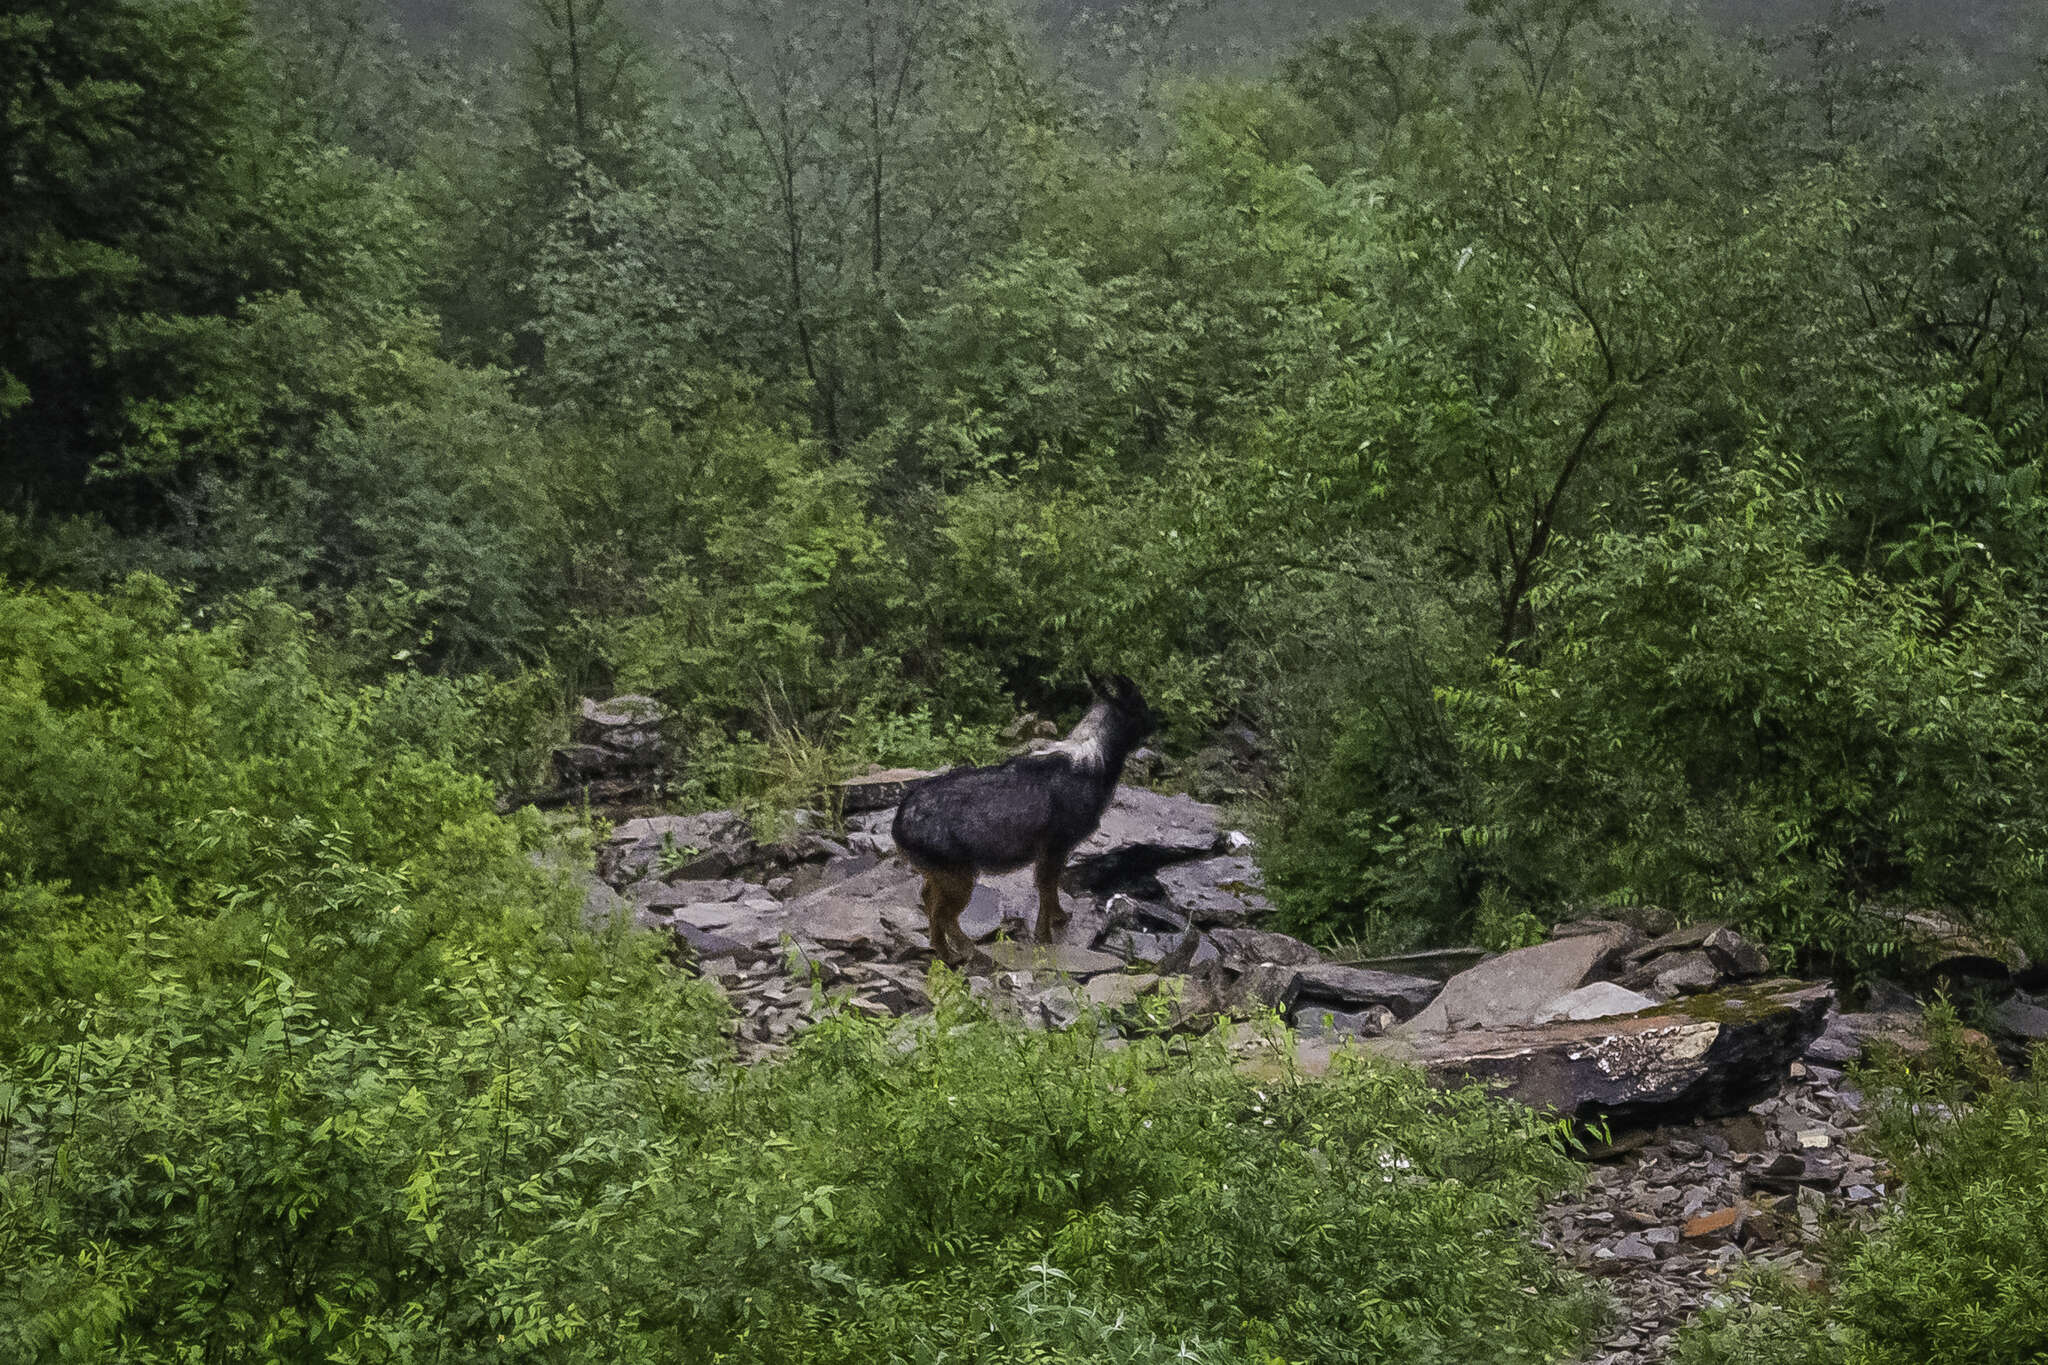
[1364,980,1835,1124]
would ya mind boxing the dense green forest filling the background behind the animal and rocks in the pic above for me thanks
[0,0,2048,966]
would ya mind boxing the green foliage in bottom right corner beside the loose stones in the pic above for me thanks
[1677,1002,2048,1365]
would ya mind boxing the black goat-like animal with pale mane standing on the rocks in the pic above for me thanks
[893,673,1153,964]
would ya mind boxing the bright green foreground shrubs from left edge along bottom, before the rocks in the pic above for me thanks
[0,579,1591,1365]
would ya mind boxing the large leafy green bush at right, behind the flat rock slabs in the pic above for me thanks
[1450,475,2048,966]
